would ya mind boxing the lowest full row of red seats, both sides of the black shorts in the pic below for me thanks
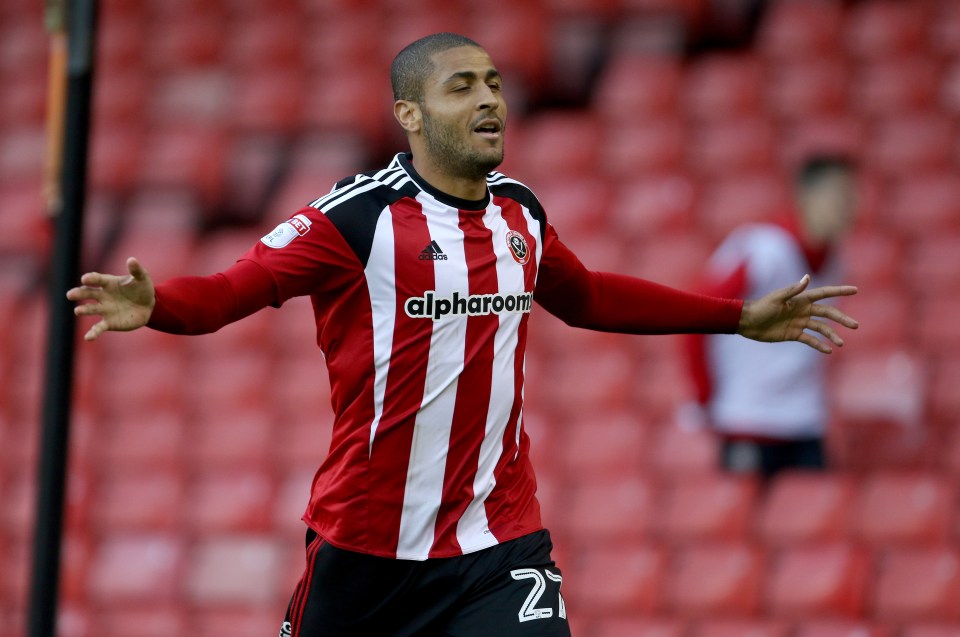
[0,533,960,634]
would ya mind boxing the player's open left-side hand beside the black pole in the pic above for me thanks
[67,257,156,341]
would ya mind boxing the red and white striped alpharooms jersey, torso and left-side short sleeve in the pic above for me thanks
[244,155,546,560]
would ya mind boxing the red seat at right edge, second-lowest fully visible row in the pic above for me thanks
[853,472,957,546]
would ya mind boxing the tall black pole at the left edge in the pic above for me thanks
[27,0,97,637]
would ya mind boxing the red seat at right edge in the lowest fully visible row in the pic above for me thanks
[871,548,960,622]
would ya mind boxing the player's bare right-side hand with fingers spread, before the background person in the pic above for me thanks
[737,275,858,354]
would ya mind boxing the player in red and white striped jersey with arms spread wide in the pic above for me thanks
[68,33,856,637]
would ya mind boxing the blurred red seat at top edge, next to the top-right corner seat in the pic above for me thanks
[844,2,927,59]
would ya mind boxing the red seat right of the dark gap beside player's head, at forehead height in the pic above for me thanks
[592,55,683,123]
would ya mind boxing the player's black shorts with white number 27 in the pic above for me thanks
[280,531,570,637]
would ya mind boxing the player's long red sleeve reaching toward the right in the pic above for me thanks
[534,224,743,334]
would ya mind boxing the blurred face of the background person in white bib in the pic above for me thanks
[800,169,857,243]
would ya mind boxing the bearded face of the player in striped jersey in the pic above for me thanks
[421,46,507,180]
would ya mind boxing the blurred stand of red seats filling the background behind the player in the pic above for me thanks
[0,0,960,637]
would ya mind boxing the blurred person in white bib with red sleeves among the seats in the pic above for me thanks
[681,155,856,479]
